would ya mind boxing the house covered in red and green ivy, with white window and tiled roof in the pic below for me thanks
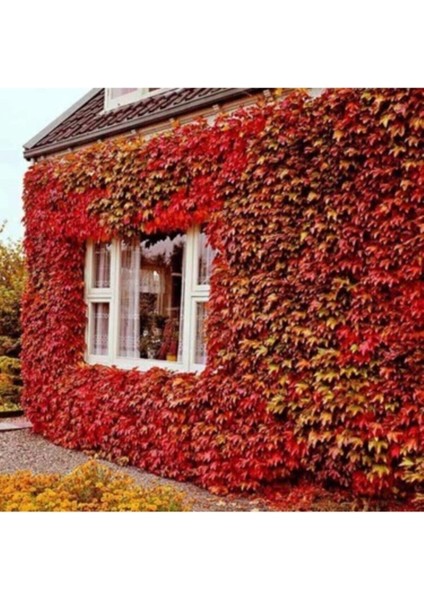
[23,88,424,494]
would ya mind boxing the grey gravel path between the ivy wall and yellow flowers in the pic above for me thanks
[0,429,270,512]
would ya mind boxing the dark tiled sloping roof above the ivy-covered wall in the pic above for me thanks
[24,88,260,158]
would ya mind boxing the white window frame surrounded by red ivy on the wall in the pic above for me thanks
[85,227,210,372]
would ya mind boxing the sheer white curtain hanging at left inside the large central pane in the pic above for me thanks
[119,243,140,358]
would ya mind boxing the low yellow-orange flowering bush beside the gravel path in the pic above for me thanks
[0,460,190,512]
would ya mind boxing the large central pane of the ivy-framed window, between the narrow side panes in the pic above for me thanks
[119,234,186,361]
